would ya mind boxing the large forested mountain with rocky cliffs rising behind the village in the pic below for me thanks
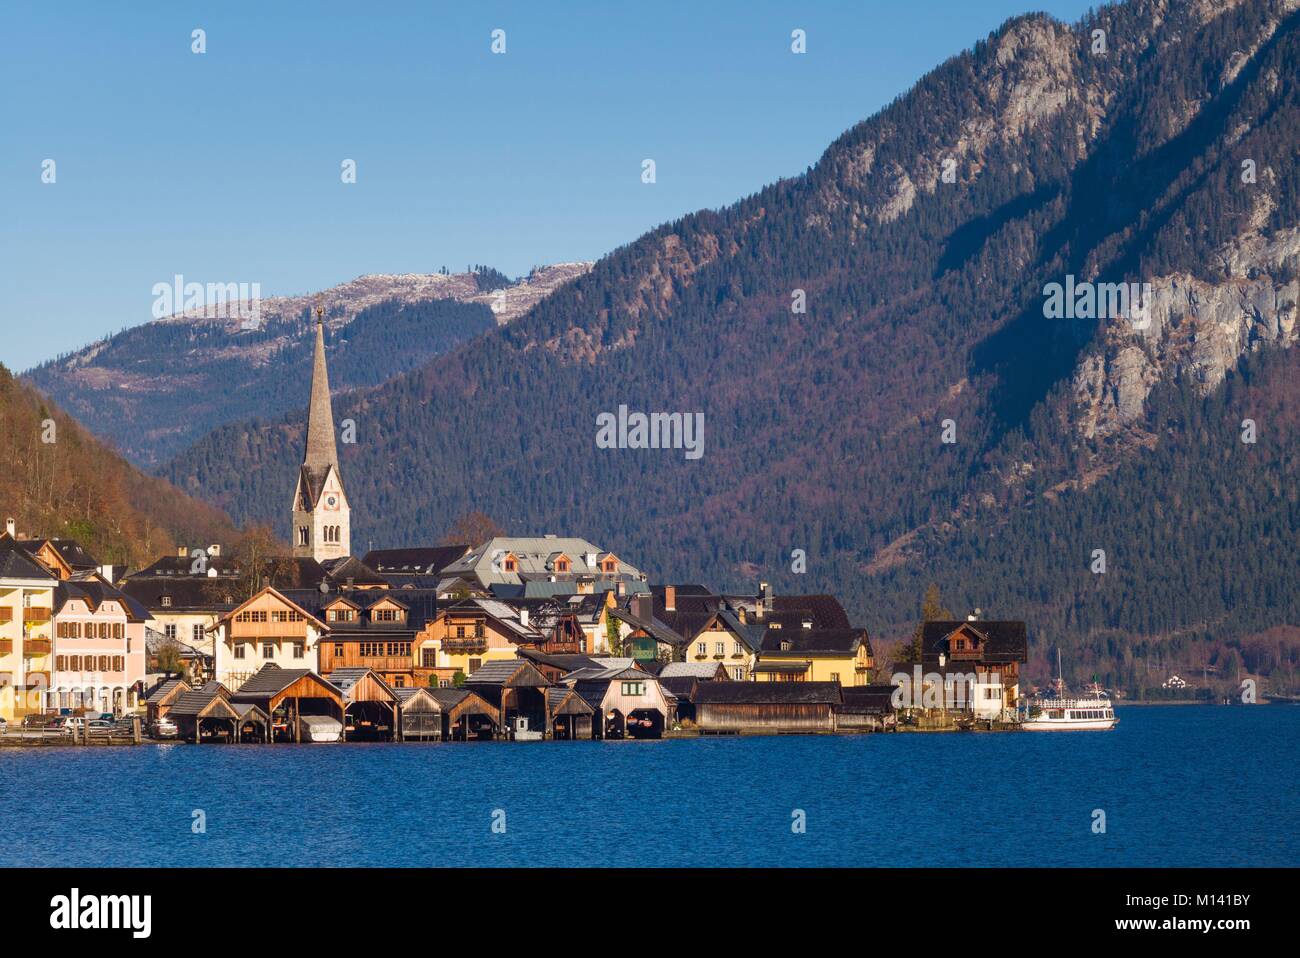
[144,0,1300,688]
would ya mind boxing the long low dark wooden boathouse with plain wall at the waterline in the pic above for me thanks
[694,682,844,732]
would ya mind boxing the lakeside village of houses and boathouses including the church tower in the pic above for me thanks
[0,320,1027,744]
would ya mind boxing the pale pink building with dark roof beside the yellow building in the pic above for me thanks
[46,573,151,714]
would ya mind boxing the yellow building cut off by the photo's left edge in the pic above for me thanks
[0,539,57,721]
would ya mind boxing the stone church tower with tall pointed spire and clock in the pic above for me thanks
[293,308,352,562]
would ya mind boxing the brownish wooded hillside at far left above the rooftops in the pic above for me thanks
[0,365,238,568]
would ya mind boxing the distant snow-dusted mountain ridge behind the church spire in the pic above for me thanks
[26,263,590,467]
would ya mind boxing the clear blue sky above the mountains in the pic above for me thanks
[0,0,1089,370]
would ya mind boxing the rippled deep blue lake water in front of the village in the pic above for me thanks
[0,706,1300,866]
